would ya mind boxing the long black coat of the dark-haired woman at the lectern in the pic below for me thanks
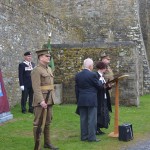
[97,72,112,128]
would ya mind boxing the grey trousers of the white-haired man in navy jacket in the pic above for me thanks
[79,106,97,141]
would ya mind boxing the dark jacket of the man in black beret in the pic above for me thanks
[18,62,35,88]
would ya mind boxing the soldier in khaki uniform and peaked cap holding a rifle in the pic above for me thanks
[31,49,58,150]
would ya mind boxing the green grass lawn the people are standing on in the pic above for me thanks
[0,95,150,150]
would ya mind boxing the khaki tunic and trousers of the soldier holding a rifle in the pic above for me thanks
[31,63,55,144]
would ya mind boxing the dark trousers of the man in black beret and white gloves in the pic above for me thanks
[21,87,33,112]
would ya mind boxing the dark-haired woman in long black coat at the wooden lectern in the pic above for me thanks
[96,61,112,135]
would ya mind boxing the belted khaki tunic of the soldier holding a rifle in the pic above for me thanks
[31,64,55,107]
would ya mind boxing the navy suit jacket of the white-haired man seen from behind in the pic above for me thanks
[75,69,102,107]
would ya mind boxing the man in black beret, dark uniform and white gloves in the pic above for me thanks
[18,52,35,113]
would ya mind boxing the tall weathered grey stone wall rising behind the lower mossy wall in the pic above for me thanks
[0,0,150,105]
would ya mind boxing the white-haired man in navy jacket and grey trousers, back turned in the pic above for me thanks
[75,58,102,142]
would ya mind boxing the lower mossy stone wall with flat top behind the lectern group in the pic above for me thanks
[52,42,143,106]
